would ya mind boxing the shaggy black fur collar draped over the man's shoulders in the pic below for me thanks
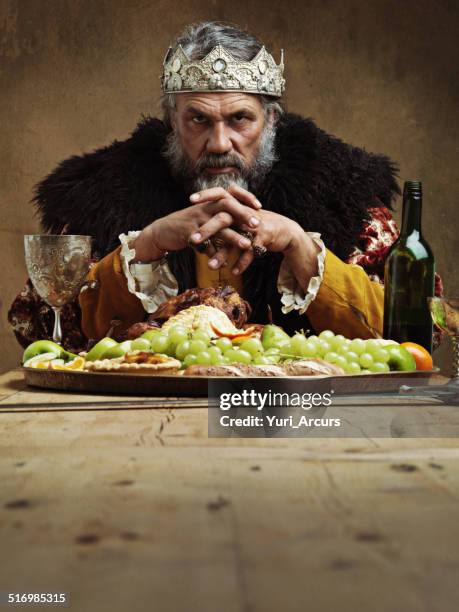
[34,114,399,322]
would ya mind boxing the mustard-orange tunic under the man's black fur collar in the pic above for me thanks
[80,247,384,340]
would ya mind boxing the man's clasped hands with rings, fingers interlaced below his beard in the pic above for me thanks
[133,185,318,287]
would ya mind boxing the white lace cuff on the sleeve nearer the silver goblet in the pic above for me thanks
[119,232,178,312]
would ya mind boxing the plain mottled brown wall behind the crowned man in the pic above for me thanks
[0,0,459,369]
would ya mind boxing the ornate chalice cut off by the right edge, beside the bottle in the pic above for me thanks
[400,297,459,403]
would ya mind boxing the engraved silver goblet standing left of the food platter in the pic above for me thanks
[24,234,91,344]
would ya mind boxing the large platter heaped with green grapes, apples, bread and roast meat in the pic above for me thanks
[19,290,435,397]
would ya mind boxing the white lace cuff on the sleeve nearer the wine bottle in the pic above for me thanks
[277,232,326,314]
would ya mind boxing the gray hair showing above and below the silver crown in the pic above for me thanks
[160,21,284,125]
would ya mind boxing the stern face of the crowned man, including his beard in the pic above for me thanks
[166,93,274,190]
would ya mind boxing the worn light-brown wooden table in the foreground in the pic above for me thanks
[0,371,459,612]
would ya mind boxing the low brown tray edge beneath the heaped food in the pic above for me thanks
[23,368,444,397]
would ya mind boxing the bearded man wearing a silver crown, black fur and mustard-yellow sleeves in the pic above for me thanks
[10,22,422,349]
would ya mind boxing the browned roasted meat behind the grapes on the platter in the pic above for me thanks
[147,285,251,329]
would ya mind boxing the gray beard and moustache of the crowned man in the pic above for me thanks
[163,124,277,193]
